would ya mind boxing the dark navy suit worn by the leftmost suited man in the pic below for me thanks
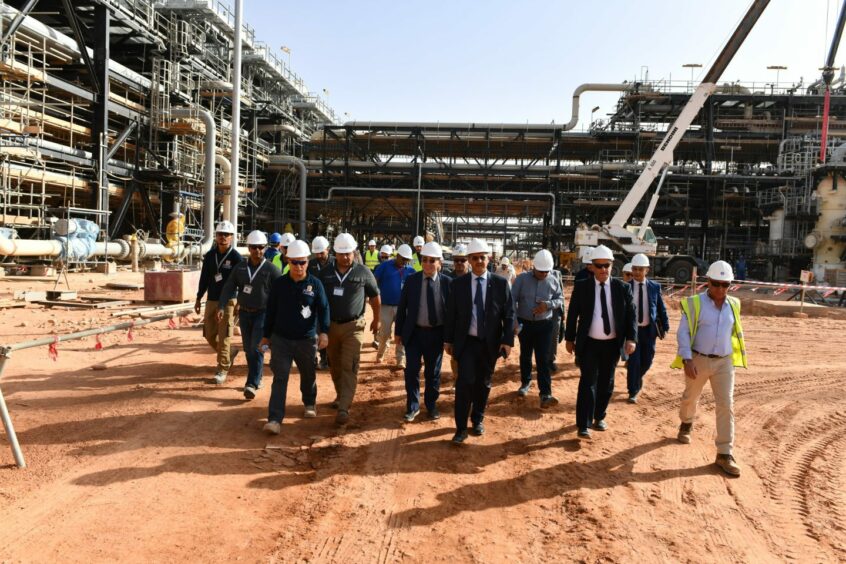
[394,272,452,413]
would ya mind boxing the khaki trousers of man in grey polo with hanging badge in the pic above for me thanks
[327,317,367,412]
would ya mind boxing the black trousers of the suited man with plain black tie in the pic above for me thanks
[576,337,620,429]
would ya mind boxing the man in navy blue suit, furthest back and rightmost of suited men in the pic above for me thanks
[626,253,670,403]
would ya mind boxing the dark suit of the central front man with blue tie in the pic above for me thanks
[444,272,514,431]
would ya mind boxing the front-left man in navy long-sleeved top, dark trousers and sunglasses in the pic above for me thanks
[261,241,329,435]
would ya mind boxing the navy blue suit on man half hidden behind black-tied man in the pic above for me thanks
[626,278,670,397]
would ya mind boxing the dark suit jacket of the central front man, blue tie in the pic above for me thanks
[444,272,514,370]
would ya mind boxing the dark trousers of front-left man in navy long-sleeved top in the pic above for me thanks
[267,335,317,423]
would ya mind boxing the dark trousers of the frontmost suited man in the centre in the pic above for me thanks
[455,336,496,431]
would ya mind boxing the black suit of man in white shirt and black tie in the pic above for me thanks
[565,277,637,430]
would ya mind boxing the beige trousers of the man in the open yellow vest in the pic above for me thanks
[679,354,734,454]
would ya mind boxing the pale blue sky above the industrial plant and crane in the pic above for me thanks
[242,0,846,130]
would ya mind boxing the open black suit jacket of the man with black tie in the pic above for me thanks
[565,276,637,357]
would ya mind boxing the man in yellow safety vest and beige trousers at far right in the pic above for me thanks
[670,260,747,476]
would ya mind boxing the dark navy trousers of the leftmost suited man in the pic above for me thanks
[403,327,444,413]
